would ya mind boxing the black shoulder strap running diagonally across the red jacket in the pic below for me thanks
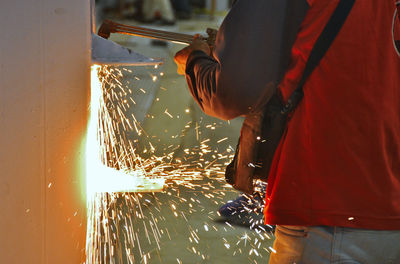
[282,0,355,113]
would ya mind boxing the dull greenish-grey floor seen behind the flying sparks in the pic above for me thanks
[92,11,273,264]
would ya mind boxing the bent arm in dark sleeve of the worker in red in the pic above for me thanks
[176,0,308,119]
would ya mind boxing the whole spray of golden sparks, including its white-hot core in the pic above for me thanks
[86,65,271,264]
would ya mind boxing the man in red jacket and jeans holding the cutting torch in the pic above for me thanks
[175,0,400,264]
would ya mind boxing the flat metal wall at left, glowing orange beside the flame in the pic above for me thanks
[0,0,91,264]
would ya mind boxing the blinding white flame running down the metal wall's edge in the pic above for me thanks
[86,65,165,264]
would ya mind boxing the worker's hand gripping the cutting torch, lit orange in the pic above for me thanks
[174,34,211,75]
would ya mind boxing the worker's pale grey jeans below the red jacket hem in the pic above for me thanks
[269,225,400,264]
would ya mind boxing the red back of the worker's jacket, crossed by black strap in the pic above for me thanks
[266,0,400,229]
